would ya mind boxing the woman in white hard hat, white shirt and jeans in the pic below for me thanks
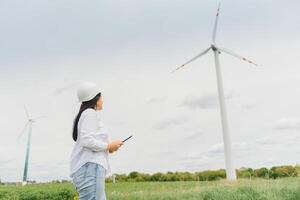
[70,82,123,200]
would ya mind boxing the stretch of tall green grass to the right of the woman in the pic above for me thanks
[107,178,300,200]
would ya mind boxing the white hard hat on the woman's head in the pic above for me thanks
[77,82,100,102]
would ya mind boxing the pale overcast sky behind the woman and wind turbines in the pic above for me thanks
[0,0,300,181]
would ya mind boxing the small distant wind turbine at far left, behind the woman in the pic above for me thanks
[18,105,45,185]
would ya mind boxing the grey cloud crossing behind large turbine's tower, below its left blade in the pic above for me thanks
[178,92,233,110]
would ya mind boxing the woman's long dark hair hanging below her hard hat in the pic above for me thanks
[72,93,101,142]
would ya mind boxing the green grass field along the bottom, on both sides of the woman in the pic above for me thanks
[0,178,300,200]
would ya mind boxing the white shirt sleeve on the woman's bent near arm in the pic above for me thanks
[80,110,108,151]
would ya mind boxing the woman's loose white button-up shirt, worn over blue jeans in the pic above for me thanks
[70,108,110,177]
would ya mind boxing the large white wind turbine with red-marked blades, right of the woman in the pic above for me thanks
[173,3,257,180]
